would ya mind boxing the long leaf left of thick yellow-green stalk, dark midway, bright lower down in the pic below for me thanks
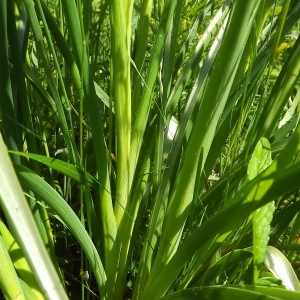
[62,1,119,298]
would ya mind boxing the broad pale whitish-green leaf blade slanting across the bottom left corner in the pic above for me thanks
[0,136,68,299]
